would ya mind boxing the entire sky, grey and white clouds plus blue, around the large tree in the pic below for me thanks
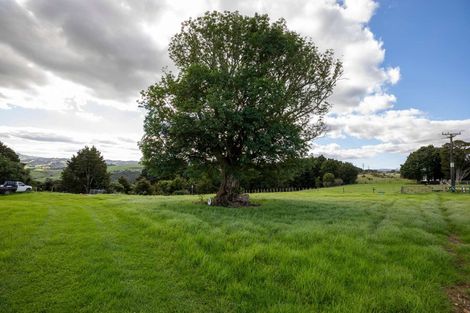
[0,0,470,168]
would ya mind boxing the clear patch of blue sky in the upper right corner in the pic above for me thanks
[370,0,470,119]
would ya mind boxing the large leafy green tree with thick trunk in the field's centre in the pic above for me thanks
[140,12,342,205]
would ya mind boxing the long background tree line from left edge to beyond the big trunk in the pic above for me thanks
[0,142,360,195]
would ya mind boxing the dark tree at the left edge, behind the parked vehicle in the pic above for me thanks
[0,142,31,184]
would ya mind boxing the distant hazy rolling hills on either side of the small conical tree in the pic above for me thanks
[20,154,143,182]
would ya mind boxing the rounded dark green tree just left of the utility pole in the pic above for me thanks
[400,145,443,181]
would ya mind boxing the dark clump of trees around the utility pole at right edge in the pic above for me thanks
[400,140,470,183]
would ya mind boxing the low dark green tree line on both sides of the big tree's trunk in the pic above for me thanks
[135,156,360,195]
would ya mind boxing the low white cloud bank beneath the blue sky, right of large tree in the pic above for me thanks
[318,109,470,159]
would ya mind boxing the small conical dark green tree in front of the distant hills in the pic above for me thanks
[62,146,110,193]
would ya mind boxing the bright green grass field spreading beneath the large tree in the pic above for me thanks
[0,183,470,313]
